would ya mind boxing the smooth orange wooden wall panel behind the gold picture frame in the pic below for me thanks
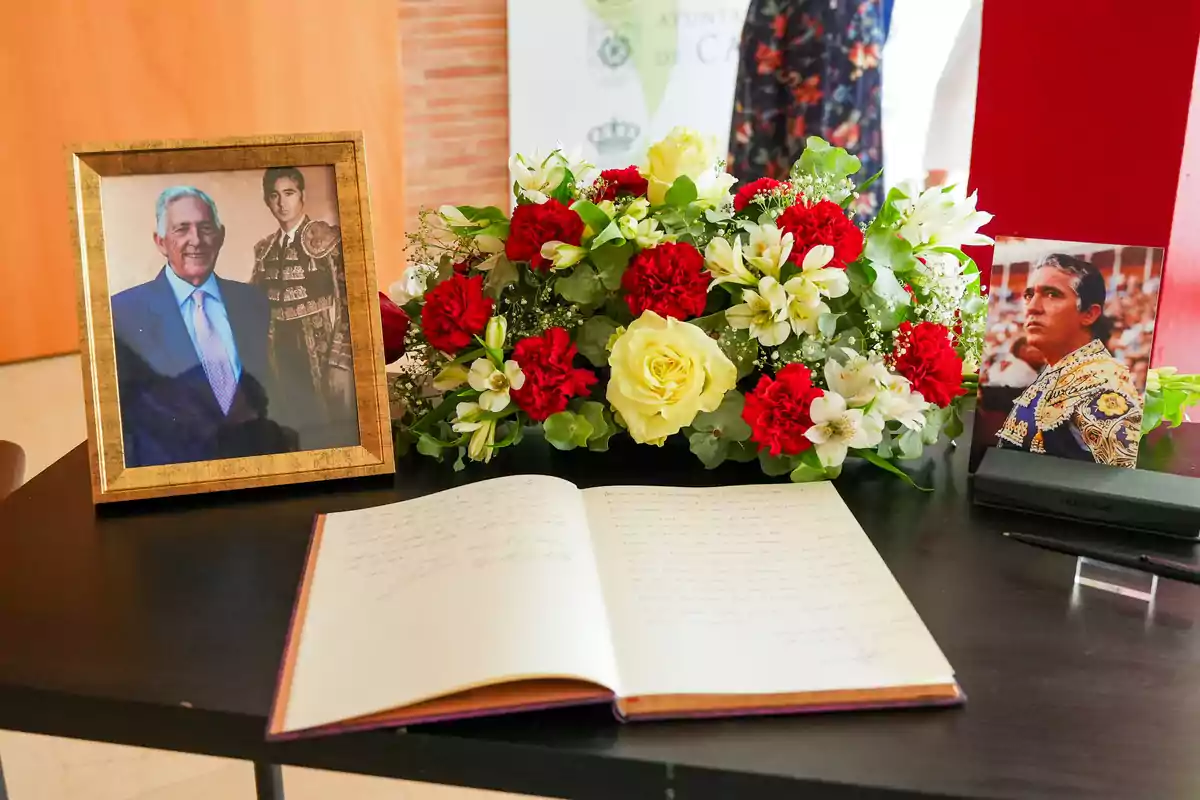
[0,0,405,362]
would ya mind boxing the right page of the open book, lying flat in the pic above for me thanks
[583,483,953,697]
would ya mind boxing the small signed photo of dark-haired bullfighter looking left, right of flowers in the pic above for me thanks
[973,237,1163,468]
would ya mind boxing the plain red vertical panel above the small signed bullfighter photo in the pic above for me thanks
[971,0,1200,291]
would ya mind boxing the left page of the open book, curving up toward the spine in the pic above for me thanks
[283,475,617,730]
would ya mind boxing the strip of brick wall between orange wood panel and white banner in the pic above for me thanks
[398,0,509,230]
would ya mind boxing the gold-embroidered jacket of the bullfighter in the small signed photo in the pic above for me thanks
[997,339,1142,468]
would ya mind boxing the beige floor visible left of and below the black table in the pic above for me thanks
[0,356,540,800]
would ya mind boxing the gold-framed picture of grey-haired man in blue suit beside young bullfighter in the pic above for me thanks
[71,134,394,503]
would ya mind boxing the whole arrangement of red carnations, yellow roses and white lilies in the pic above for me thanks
[384,128,991,481]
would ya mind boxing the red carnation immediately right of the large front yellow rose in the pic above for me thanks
[742,363,824,456]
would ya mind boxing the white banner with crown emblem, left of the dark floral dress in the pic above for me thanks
[509,0,749,169]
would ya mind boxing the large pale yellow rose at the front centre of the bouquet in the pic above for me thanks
[607,311,738,445]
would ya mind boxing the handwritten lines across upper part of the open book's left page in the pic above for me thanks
[324,477,580,595]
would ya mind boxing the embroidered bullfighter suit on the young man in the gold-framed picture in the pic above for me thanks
[251,217,358,449]
